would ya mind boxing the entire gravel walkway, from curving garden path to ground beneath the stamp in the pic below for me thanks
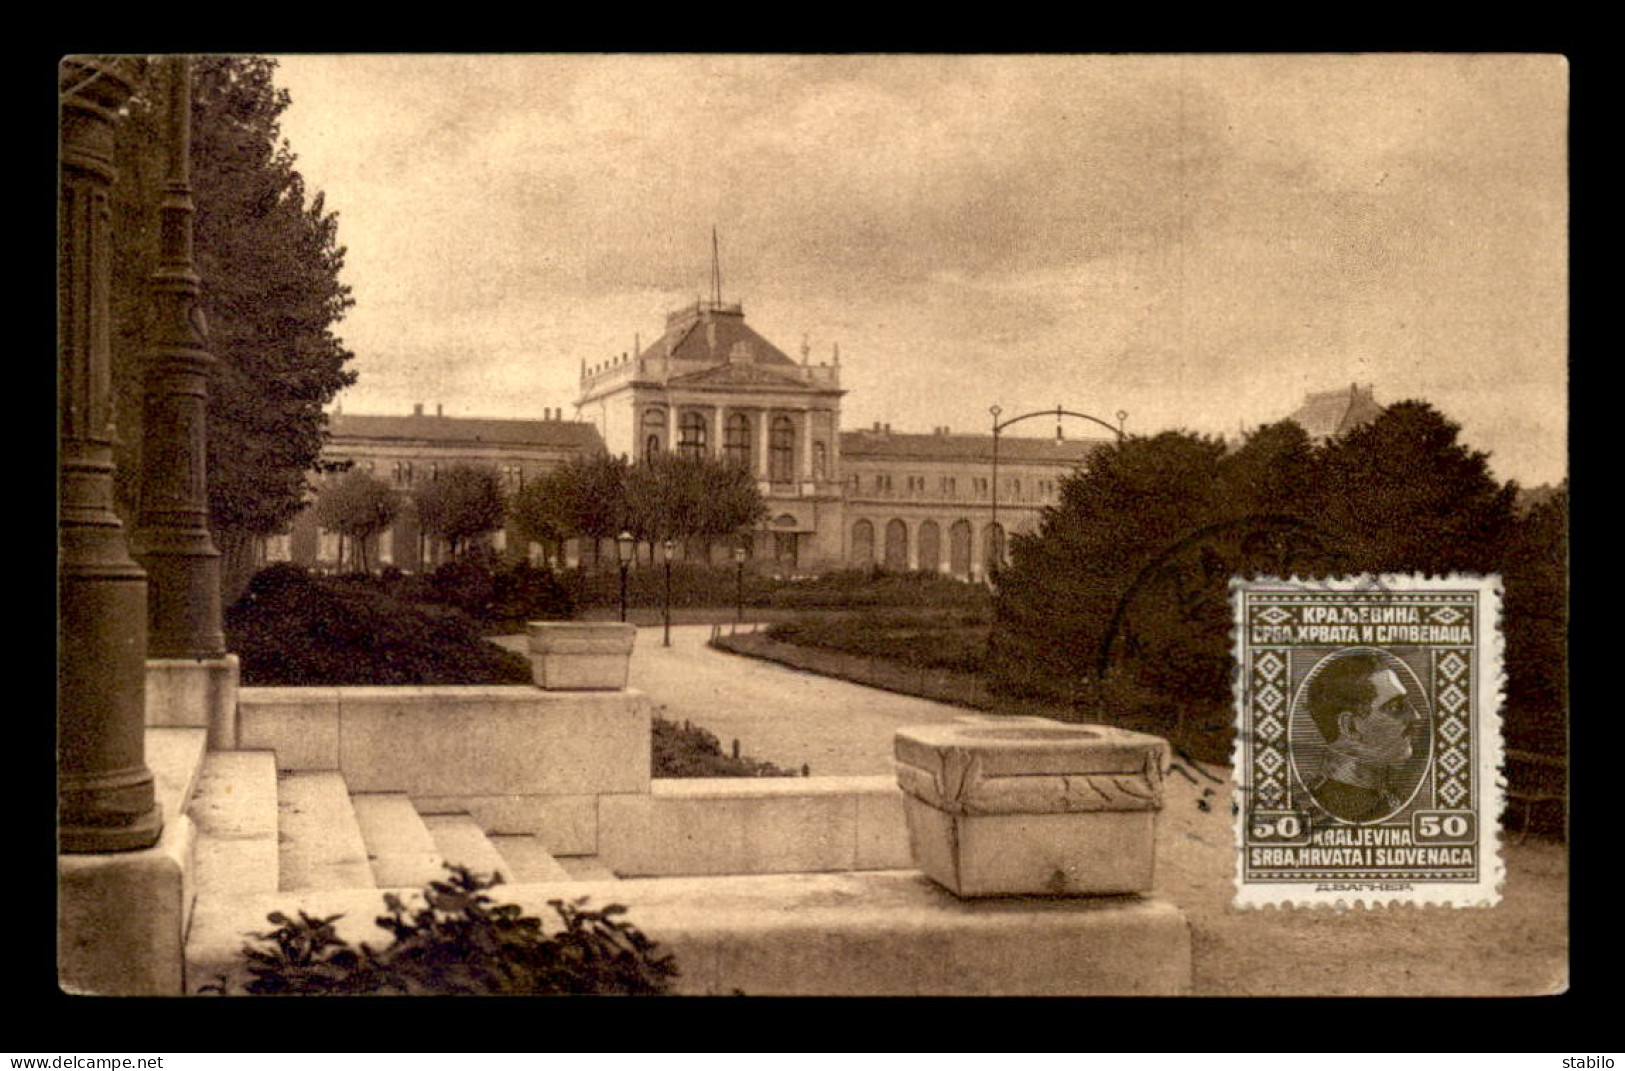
[487,626,1568,996]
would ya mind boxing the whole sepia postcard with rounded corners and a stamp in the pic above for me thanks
[55,52,1570,999]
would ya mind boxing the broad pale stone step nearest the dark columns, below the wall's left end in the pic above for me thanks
[187,751,281,895]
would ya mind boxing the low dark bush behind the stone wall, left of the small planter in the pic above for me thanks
[224,564,531,686]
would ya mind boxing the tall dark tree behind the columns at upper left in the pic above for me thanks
[112,57,356,588]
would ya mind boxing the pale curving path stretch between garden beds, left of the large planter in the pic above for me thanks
[499,624,970,777]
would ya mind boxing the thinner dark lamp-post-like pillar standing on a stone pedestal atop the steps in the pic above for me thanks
[135,55,226,658]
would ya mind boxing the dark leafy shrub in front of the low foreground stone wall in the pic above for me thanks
[205,865,678,996]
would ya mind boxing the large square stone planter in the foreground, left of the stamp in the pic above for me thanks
[895,718,1168,897]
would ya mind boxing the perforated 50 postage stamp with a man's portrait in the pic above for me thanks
[1230,575,1503,907]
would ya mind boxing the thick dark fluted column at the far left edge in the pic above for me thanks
[57,57,163,852]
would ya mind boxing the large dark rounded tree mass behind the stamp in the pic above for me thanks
[990,401,1534,761]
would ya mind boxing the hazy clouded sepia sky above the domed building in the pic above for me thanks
[280,55,1568,484]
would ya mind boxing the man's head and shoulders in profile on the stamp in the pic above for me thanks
[1305,650,1422,822]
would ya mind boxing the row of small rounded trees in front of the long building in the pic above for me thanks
[314,453,767,570]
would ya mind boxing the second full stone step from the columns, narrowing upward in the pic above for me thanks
[276,770,377,891]
